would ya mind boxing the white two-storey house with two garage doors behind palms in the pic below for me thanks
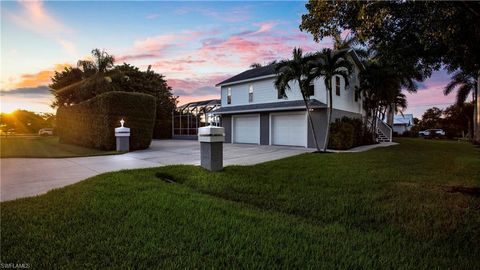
[212,50,380,148]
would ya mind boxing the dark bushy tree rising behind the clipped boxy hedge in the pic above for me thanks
[50,49,176,138]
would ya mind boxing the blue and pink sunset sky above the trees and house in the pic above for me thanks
[0,1,464,117]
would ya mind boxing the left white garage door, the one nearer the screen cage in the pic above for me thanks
[232,115,260,144]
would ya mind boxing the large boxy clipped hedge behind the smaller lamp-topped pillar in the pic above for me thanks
[57,91,156,150]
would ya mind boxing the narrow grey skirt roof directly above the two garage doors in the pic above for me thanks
[212,99,327,114]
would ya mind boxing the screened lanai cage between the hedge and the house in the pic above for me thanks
[172,99,221,140]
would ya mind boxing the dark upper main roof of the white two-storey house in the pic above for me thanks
[215,49,365,86]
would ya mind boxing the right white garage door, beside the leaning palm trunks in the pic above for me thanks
[271,112,307,147]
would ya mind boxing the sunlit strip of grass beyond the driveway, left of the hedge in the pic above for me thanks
[0,136,118,158]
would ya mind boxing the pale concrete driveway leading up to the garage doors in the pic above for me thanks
[0,140,313,201]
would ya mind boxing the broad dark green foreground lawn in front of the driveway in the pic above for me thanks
[0,139,480,269]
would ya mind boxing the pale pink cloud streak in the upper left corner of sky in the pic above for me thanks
[6,0,76,55]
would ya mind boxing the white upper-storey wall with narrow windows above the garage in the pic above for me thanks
[221,66,362,116]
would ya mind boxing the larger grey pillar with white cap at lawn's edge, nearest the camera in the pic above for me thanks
[198,126,225,171]
